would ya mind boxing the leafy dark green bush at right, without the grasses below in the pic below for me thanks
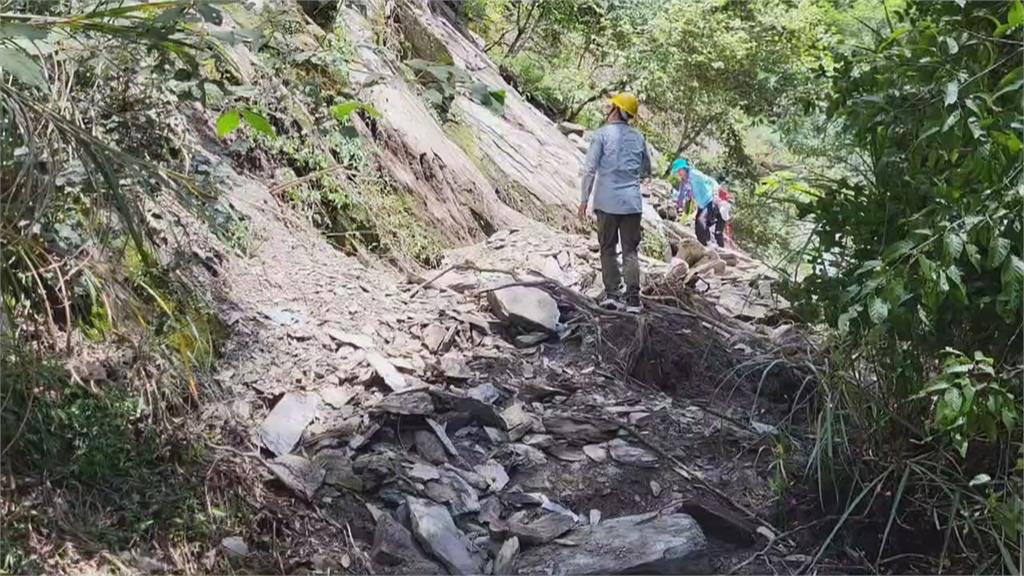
[803,3,1024,379]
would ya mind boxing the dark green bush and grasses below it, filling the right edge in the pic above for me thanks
[796,1,1024,573]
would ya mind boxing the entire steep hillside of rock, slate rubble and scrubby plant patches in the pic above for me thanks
[4,1,803,574]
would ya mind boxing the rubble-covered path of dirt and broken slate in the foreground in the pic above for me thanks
[197,169,790,573]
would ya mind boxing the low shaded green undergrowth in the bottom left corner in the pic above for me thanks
[0,339,245,573]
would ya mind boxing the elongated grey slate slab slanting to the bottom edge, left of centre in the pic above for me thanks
[406,496,483,574]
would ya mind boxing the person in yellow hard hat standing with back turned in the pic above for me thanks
[579,92,650,312]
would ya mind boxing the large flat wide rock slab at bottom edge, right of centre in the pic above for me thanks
[517,513,711,574]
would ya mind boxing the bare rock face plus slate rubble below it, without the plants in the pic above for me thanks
[46,0,799,574]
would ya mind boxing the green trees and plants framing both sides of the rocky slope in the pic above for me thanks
[0,0,1024,574]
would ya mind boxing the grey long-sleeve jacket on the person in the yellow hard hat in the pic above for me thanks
[580,122,650,214]
